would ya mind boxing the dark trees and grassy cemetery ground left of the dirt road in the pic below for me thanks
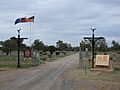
[0,37,79,70]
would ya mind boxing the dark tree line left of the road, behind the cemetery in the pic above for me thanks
[0,37,79,55]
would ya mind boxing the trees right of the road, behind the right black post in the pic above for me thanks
[80,39,120,52]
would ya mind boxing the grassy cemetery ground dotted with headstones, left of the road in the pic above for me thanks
[0,50,74,70]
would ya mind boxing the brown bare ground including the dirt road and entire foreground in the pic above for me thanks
[0,54,120,90]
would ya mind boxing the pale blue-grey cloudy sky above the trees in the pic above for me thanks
[0,0,120,46]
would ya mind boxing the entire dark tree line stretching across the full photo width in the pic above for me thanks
[0,37,120,55]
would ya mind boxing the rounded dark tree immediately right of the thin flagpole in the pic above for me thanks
[33,39,45,51]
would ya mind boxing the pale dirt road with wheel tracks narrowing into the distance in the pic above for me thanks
[0,54,78,90]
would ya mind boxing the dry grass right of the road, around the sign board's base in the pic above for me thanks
[66,52,120,83]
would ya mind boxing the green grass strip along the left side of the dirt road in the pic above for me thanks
[0,52,74,69]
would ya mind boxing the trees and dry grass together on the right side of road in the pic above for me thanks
[66,40,120,82]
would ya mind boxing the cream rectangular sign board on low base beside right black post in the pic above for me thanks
[95,55,110,66]
